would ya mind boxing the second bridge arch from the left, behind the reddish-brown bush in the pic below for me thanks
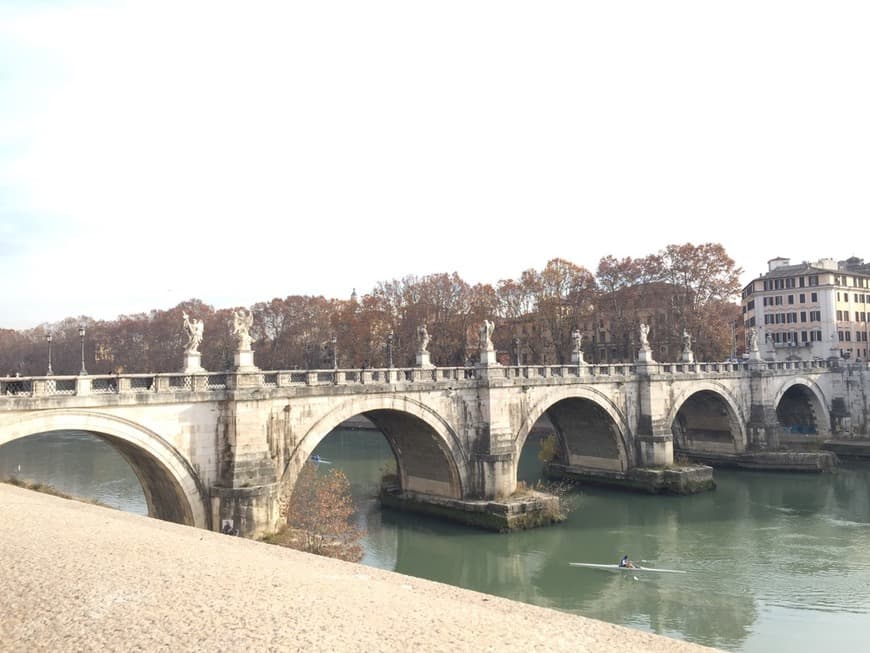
[281,395,469,499]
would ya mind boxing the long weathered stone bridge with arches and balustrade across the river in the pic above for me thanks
[0,360,867,536]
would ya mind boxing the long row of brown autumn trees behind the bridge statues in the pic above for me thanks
[0,243,740,375]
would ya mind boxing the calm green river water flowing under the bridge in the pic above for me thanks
[0,429,870,653]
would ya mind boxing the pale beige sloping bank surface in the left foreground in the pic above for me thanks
[0,484,713,653]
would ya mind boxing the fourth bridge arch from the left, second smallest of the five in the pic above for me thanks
[665,380,746,455]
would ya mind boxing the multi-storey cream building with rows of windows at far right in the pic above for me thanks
[742,257,870,360]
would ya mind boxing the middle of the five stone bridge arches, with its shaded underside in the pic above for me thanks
[514,386,634,472]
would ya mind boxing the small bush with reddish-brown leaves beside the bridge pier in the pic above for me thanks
[269,462,365,562]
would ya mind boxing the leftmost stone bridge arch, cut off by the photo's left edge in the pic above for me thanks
[0,410,211,529]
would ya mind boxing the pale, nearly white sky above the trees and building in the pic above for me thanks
[0,0,870,329]
